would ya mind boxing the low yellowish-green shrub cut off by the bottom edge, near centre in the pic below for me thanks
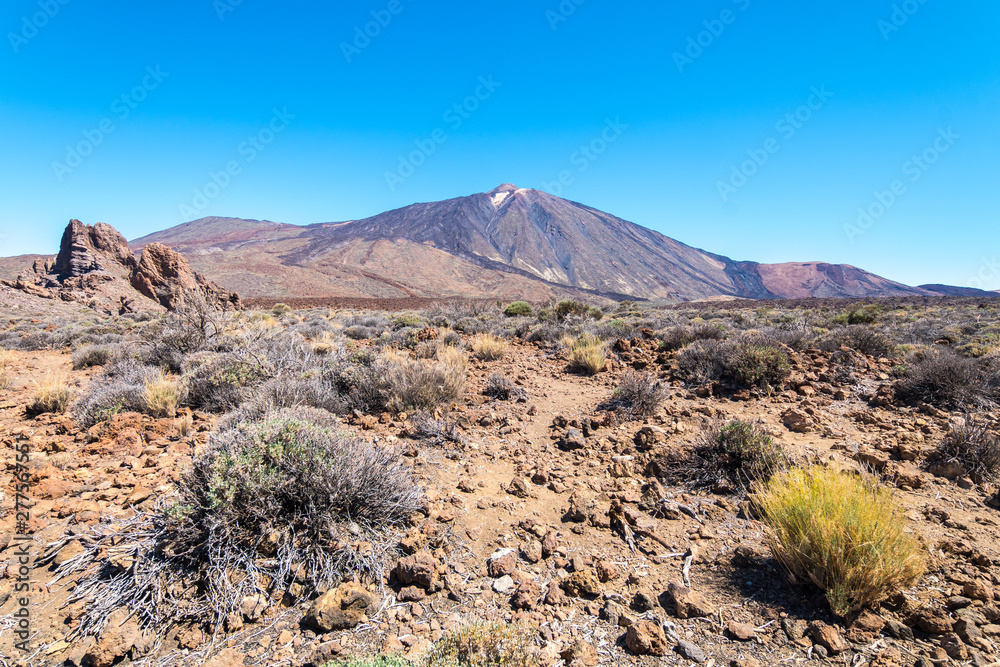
[424,623,538,667]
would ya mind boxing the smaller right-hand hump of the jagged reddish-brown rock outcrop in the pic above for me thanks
[131,243,240,310]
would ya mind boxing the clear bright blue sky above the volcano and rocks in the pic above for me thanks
[0,0,1000,289]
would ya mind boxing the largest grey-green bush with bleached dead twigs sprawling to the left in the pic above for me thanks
[57,409,423,638]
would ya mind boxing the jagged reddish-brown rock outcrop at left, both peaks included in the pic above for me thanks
[8,220,241,314]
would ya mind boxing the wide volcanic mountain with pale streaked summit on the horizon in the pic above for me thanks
[131,184,952,300]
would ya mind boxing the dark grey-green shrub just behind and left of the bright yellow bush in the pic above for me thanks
[684,419,787,489]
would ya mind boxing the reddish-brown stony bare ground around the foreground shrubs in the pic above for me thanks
[0,328,1000,667]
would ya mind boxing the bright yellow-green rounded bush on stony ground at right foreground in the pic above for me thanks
[754,467,925,616]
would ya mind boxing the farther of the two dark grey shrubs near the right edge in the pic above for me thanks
[896,351,988,409]
